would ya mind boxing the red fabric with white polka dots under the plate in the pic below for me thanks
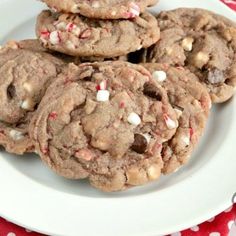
[0,0,236,236]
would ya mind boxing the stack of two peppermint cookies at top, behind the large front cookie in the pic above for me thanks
[36,0,160,61]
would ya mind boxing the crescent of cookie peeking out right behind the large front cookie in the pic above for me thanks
[143,63,211,174]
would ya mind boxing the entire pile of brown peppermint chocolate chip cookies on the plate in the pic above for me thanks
[0,0,236,191]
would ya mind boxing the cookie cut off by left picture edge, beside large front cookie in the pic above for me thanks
[0,42,64,154]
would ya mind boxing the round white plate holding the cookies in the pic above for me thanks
[0,0,236,236]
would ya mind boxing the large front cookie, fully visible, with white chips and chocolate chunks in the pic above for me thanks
[30,62,178,191]
